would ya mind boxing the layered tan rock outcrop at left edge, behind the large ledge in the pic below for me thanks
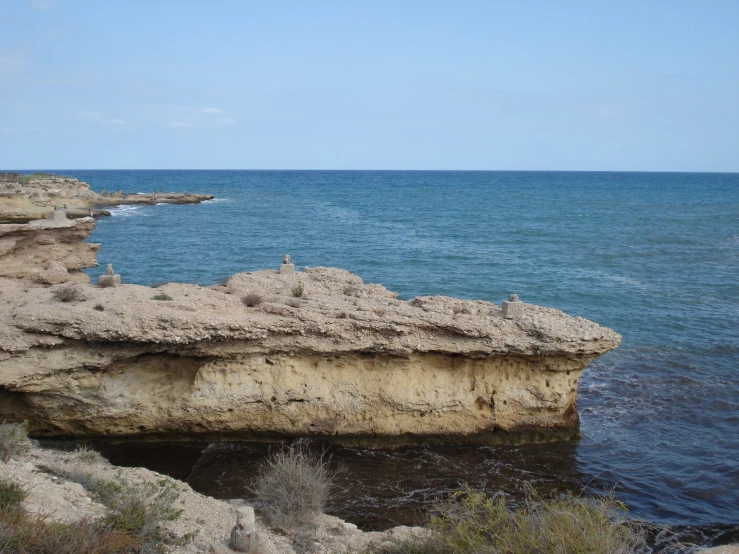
[0,216,100,284]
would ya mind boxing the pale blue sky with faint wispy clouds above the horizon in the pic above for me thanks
[0,0,739,172]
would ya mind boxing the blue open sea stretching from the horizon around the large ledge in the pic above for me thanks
[60,171,739,525]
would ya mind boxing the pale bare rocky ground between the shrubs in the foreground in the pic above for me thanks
[0,448,426,554]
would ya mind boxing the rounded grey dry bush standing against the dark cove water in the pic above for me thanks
[251,440,336,530]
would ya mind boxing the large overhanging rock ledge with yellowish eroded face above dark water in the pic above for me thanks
[0,268,620,444]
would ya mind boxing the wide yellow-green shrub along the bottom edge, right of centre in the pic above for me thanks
[404,487,645,554]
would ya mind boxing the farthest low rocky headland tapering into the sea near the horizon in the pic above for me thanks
[0,175,213,224]
